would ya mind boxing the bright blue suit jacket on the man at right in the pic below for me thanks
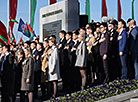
[119,30,128,53]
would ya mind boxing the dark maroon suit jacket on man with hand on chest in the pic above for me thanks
[100,32,109,56]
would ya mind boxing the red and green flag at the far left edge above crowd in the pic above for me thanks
[0,21,8,45]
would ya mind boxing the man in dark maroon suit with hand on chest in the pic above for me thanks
[99,23,109,83]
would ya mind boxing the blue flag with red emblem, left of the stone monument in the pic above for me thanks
[18,18,31,38]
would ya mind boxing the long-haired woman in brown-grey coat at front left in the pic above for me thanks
[21,48,34,102]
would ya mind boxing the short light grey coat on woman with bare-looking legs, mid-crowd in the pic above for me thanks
[75,42,87,67]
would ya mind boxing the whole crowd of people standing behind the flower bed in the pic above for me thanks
[0,19,138,102]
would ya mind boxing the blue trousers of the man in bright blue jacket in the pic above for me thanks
[120,54,128,79]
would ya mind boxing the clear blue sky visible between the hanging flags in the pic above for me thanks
[0,0,138,42]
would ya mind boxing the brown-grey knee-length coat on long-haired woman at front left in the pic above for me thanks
[21,57,34,91]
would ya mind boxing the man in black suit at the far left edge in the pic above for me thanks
[1,45,14,102]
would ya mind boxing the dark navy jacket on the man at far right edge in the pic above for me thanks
[129,27,138,59]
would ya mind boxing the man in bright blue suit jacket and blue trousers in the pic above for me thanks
[118,19,128,79]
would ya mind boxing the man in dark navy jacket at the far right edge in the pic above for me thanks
[129,20,138,80]
